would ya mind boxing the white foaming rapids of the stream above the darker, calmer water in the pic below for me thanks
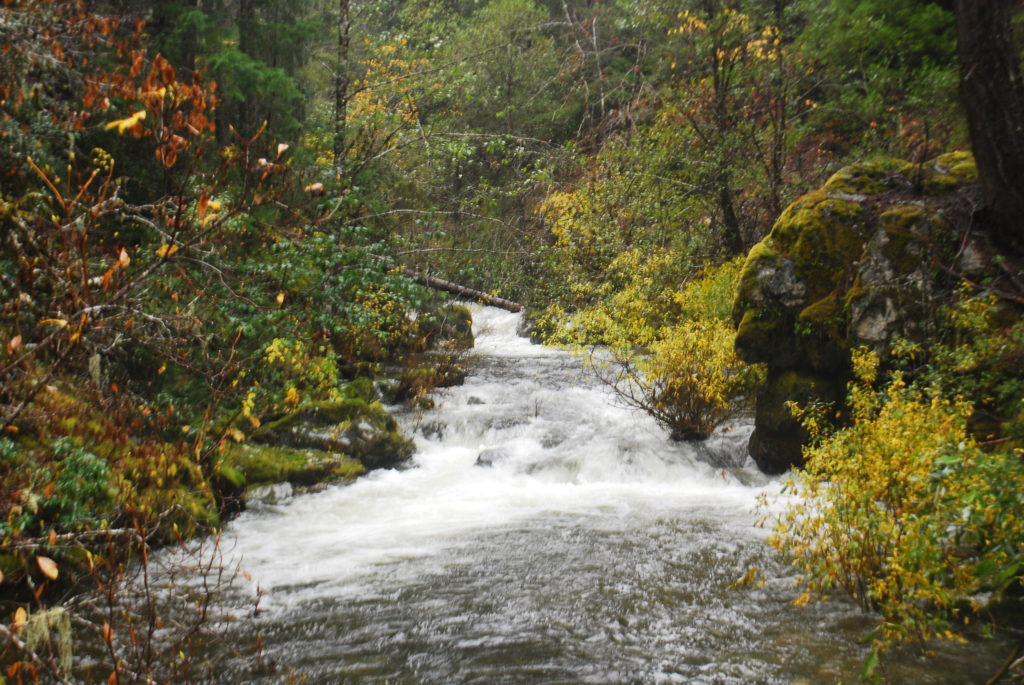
[225,307,759,600]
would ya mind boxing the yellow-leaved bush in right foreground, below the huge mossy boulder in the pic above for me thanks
[771,351,1024,648]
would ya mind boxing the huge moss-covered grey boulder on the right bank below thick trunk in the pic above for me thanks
[733,153,985,473]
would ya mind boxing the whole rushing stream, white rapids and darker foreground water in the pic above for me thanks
[225,308,1000,684]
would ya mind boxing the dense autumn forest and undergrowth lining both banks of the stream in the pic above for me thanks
[0,0,1024,682]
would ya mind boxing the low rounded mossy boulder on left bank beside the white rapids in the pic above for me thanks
[250,399,414,475]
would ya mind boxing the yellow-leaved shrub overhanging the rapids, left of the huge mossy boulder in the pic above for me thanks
[561,250,763,440]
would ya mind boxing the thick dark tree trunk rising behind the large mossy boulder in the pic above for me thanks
[955,0,1024,253]
